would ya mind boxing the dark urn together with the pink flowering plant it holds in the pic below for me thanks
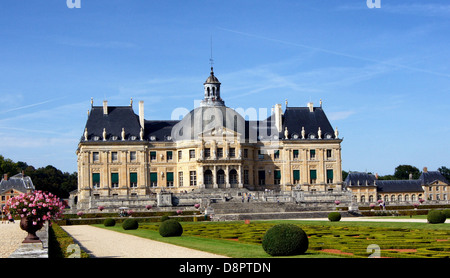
[6,190,64,243]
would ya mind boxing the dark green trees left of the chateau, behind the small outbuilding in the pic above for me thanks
[0,155,78,198]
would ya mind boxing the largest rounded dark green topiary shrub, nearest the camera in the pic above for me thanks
[262,224,309,256]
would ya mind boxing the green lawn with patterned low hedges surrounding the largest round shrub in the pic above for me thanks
[95,220,450,258]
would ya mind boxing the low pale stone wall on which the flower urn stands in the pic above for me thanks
[9,221,49,258]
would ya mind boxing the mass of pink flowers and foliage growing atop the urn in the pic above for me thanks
[6,190,64,225]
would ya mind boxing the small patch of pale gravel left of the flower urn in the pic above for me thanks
[0,221,27,258]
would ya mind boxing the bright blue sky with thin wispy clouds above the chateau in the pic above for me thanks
[0,0,450,175]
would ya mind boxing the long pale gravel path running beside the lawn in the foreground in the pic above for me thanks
[61,225,229,258]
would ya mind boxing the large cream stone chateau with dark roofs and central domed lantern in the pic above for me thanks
[76,68,342,207]
